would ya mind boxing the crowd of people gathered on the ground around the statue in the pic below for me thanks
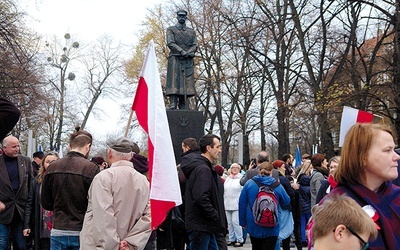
[0,94,400,250]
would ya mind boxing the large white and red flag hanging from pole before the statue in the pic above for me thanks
[132,41,182,230]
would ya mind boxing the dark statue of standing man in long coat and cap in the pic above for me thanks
[165,10,198,109]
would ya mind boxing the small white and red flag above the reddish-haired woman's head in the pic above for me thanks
[339,106,374,147]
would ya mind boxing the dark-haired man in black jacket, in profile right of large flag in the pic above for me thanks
[182,134,227,250]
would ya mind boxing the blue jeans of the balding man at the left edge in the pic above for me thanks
[0,213,26,250]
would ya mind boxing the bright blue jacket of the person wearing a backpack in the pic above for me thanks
[239,175,290,238]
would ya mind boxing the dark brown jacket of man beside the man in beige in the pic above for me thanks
[41,152,100,231]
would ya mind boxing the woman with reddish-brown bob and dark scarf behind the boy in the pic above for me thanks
[327,123,400,250]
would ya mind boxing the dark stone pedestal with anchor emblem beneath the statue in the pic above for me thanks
[167,109,204,164]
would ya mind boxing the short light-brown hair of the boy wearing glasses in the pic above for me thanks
[312,194,378,241]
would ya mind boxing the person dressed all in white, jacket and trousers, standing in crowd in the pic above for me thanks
[224,163,243,247]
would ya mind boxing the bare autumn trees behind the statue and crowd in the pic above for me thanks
[0,0,400,168]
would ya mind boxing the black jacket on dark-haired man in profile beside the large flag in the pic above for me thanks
[182,155,227,233]
